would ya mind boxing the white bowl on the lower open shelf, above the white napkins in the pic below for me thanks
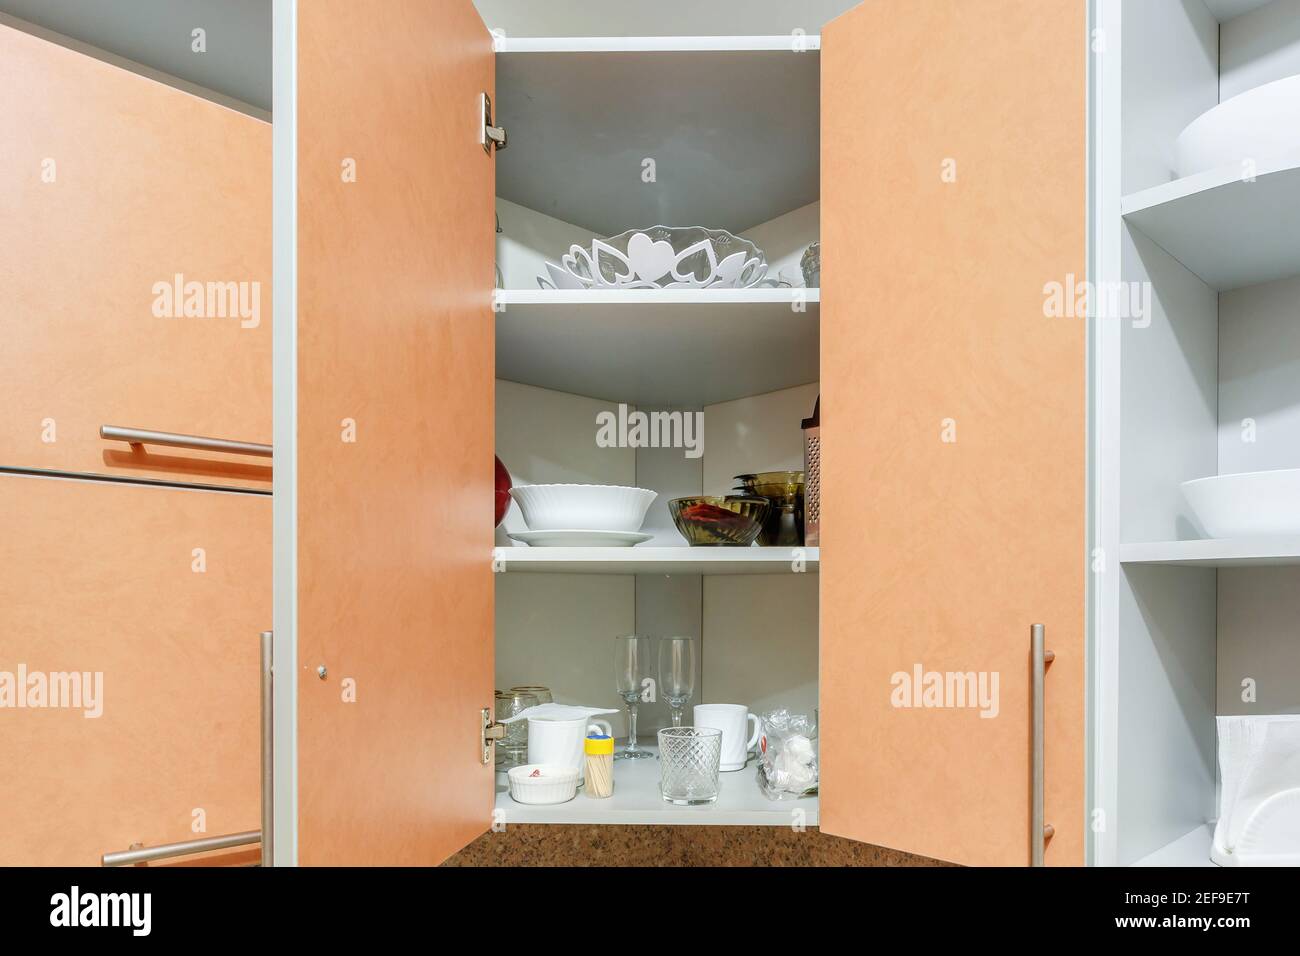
[1182,468,1300,537]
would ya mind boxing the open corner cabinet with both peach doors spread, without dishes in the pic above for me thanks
[276,0,1089,864]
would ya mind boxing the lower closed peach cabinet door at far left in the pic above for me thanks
[0,475,270,866]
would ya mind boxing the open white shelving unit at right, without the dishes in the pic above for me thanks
[1092,0,1300,865]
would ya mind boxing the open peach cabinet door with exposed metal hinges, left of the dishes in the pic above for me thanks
[296,0,495,865]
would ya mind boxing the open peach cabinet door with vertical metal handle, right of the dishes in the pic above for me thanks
[820,0,1088,865]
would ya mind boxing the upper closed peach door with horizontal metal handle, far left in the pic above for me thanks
[0,26,270,490]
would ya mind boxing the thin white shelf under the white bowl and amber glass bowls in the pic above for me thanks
[493,545,820,575]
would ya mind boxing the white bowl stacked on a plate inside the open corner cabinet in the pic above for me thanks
[510,484,658,548]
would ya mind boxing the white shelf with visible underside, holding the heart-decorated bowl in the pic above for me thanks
[497,289,820,408]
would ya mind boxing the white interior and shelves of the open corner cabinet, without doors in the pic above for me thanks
[495,36,819,826]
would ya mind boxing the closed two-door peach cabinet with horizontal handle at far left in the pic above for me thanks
[0,23,272,866]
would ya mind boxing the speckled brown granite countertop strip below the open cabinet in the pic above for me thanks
[443,823,953,866]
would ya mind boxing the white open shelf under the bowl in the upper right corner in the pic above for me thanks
[1121,165,1300,291]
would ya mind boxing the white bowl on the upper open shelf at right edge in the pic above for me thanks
[1174,75,1300,178]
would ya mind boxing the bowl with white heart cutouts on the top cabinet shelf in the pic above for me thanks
[537,226,767,289]
